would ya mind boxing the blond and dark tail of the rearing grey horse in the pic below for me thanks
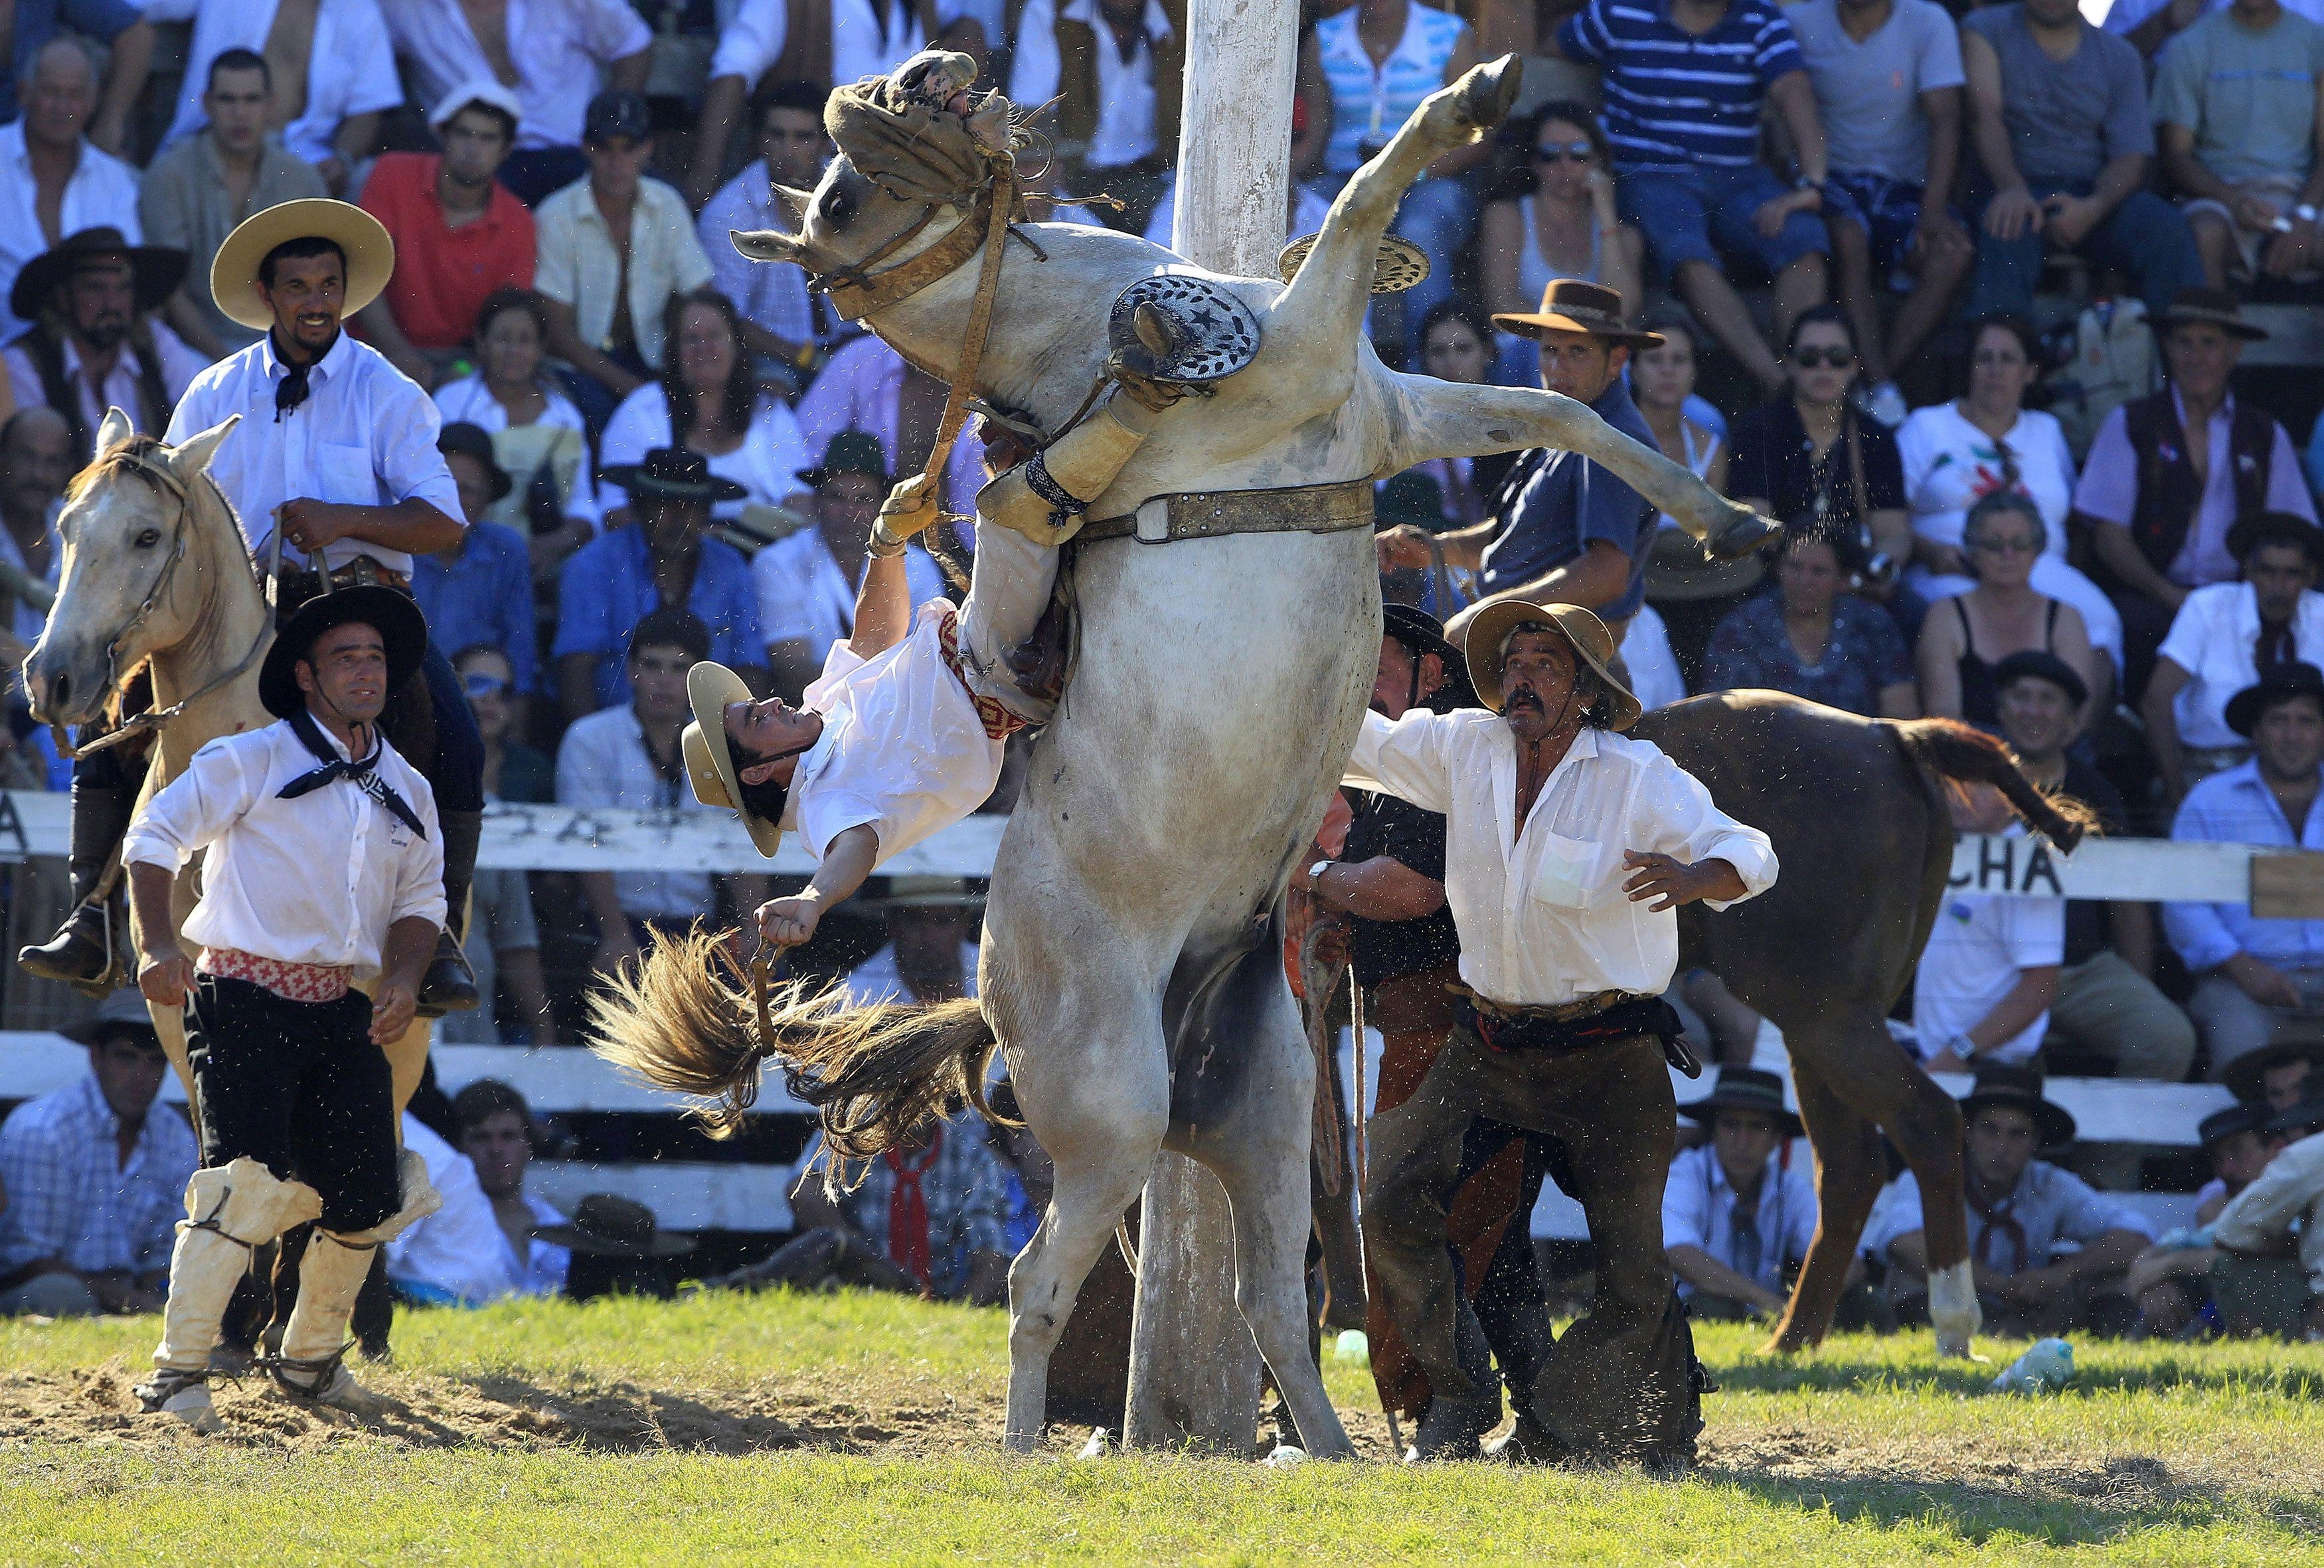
[590,925,999,1159]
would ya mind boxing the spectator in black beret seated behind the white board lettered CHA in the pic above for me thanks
[1994,651,2194,1091]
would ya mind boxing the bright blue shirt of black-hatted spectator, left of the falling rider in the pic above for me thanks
[556,527,767,708]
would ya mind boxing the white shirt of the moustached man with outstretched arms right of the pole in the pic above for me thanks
[1346,708,1776,1006]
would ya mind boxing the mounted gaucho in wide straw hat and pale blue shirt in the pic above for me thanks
[17,200,483,1013]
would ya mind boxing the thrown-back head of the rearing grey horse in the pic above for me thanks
[734,48,1011,287]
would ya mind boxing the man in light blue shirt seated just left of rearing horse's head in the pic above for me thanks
[695,81,839,388]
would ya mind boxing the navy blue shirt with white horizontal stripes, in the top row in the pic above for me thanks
[1557,0,1806,174]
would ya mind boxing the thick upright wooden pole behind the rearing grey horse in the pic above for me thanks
[1123,0,1306,1456]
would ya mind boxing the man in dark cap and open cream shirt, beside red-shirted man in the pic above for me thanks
[533,95,711,428]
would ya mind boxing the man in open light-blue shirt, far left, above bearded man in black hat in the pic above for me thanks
[0,37,144,339]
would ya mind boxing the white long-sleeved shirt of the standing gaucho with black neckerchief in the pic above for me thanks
[121,720,444,985]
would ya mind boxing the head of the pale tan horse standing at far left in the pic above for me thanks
[23,409,240,725]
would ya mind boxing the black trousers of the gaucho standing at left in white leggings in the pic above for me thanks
[186,973,404,1236]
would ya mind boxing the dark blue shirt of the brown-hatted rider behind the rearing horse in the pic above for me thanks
[1481,376,1662,620]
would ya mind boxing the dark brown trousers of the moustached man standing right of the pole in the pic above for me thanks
[1365,1027,1701,1459]
